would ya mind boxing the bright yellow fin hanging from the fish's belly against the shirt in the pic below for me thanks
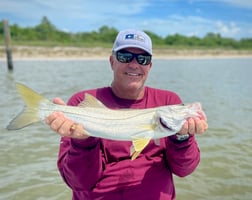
[131,138,150,160]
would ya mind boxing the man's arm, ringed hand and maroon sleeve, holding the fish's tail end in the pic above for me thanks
[46,98,102,190]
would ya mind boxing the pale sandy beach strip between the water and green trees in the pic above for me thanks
[0,46,252,60]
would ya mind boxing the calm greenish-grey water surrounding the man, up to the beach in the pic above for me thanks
[0,58,252,200]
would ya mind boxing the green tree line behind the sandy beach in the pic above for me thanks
[0,17,252,49]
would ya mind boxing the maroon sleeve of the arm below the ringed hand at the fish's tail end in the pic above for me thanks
[58,137,102,191]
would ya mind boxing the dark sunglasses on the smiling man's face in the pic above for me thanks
[114,50,151,65]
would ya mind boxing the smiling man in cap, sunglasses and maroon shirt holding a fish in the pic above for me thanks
[46,30,208,200]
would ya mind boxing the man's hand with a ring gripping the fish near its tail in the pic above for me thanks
[46,98,89,139]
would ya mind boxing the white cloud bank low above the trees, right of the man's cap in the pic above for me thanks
[132,15,251,39]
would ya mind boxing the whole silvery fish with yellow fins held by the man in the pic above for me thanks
[7,83,203,159]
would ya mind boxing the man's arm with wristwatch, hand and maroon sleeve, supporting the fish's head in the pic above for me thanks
[166,115,208,177]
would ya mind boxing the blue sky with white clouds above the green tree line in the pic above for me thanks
[0,0,252,40]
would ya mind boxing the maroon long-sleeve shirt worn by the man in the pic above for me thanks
[58,87,200,200]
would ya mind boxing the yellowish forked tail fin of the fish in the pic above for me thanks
[6,83,50,130]
